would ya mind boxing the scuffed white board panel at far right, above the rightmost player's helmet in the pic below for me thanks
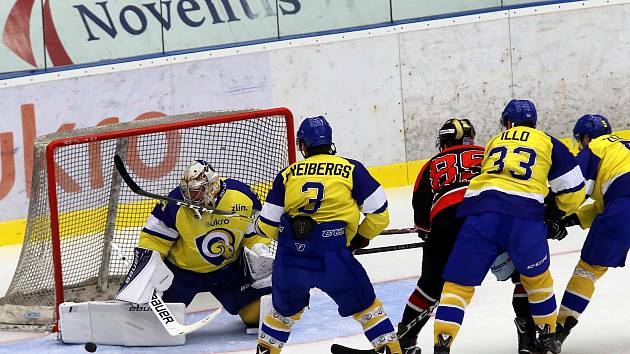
[510,4,630,136]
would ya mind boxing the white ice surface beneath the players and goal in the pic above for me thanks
[0,187,630,354]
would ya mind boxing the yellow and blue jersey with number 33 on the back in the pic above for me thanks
[458,126,584,220]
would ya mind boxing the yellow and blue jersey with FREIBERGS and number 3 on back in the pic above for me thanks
[258,154,389,242]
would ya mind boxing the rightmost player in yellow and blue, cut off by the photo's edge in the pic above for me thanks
[558,114,630,348]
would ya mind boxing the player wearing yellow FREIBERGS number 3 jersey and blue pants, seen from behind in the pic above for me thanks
[257,116,401,354]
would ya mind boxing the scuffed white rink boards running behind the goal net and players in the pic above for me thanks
[0,0,630,242]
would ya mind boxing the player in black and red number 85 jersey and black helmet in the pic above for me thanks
[397,118,536,354]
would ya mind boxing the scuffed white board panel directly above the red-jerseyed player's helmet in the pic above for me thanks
[400,19,512,160]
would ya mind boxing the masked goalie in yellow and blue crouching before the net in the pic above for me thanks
[116,160,273,332]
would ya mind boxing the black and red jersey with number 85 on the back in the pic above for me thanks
[412,145,484,230]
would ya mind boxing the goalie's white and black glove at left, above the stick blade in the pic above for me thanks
[114,247,174,304]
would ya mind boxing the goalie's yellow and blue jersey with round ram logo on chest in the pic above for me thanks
[138,179,269,273]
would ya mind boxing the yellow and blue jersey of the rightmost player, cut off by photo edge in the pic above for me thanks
[577,135,630,228]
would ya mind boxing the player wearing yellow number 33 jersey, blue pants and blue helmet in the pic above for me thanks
[434,100,584,354]
